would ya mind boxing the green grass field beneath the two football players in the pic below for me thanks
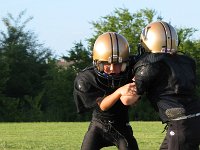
[0,122,165,150]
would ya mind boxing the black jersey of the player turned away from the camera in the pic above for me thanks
[134,53,200,122]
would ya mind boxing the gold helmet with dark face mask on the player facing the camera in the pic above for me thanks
[93,32,130,88]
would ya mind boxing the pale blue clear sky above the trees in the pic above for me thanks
[0,0,200,56]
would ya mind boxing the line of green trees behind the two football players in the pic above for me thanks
[0,8,200,122]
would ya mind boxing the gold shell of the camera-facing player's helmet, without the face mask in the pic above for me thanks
[93,32,129,72]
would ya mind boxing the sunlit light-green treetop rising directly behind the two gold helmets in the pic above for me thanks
[88,8,161,54]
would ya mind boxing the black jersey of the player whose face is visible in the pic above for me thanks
[74,67,132,122]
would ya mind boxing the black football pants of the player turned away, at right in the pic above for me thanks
[160,116,200,150]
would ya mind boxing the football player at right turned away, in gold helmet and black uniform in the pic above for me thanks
[121,21,200,150]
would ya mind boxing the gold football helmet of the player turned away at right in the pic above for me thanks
[140,21,178,53]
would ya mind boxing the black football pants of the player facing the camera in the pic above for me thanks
[81,119,138,150]
